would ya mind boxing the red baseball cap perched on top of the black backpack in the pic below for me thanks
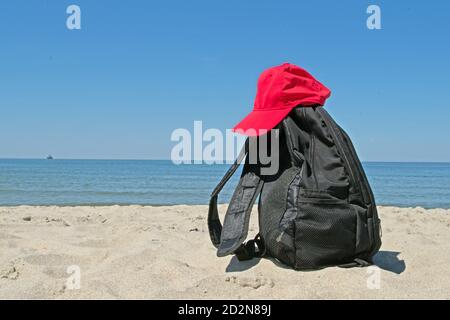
[233,63,331,136]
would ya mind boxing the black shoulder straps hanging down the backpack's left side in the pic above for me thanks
[208,139,263,260]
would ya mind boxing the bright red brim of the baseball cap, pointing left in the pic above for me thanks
[232,108,293,136]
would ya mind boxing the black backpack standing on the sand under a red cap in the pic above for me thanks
[208,106,381,269]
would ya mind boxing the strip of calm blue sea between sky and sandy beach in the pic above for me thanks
[0,159,450,208]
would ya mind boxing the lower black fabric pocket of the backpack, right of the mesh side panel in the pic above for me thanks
[295,199,356,269]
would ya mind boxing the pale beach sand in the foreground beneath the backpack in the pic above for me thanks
[0,205,450,299]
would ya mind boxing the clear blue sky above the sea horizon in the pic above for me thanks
[0,0,450,161]
